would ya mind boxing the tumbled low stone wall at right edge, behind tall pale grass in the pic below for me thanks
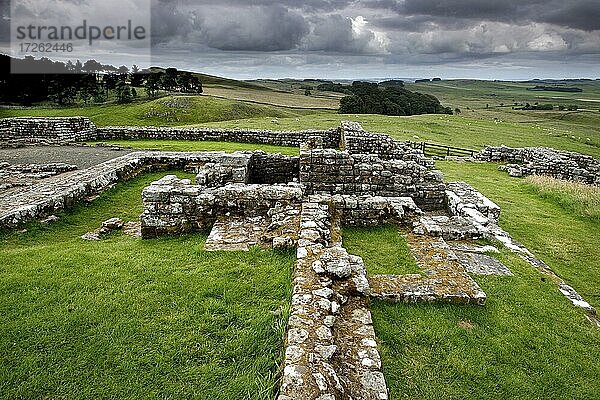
[475,146,600,185]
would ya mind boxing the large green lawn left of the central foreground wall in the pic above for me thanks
[0,173,294,399]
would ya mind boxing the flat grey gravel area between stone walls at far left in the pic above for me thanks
[0,146,134,169]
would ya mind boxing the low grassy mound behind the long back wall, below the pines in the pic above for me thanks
[0,96,322,126]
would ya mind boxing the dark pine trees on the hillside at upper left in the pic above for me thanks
[0,55,202,106]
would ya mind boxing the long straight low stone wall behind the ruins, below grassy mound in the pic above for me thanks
[97,126,340,148]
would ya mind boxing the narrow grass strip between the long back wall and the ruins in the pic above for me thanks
[88,140,300,156]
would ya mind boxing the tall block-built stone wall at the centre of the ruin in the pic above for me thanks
[300,144,446,210]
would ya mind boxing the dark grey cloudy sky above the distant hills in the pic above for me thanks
[0,0,600,79]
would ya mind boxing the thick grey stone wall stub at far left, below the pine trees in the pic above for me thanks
[0,117,96,147]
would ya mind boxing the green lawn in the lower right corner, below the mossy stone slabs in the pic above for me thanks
[371,245,600,400]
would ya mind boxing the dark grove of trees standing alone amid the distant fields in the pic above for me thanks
[339,81,452,115]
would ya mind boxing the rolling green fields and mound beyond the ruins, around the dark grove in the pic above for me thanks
[0,76,600,157]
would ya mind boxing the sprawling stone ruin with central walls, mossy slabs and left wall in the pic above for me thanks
[0,117,596,400]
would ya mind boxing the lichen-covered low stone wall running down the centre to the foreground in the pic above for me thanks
[278,198,389,400]
